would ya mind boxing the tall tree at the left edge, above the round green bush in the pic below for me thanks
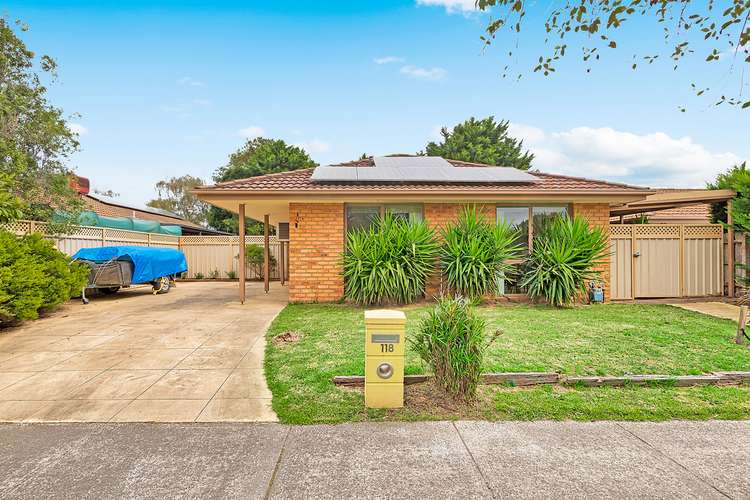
[0,18,82,228]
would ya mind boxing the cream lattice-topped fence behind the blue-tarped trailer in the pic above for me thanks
[2,220,288,279]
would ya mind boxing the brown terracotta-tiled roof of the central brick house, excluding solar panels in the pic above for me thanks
[195,158,651,195]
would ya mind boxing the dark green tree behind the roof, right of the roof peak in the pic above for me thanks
[425,116,534,170]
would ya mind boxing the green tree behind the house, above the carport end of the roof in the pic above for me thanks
[208,137,318,234]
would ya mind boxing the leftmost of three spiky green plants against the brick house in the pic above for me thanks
[343,213,438,305]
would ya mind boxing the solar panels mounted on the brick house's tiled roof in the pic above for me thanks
[312,156,539,184]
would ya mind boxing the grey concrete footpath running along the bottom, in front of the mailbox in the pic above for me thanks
[0,421,750,499]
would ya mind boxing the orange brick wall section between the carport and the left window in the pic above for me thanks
[289,203,344,302]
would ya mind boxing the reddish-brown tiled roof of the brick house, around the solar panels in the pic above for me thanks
[199,166,647,193]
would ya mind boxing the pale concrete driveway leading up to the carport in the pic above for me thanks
[0,282,287,422]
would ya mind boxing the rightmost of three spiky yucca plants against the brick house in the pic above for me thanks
[521,217,609,307]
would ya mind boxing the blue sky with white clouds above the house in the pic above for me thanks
[4,0,750,203]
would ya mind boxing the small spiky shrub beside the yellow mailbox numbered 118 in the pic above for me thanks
[410,297,494,400]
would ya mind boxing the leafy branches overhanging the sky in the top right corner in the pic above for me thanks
[476,0,750,111]
